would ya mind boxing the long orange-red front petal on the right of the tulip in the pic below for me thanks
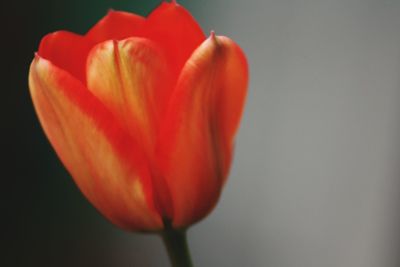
[159,36,248,227]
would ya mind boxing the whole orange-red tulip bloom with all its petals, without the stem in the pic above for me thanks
[29,1,248,266]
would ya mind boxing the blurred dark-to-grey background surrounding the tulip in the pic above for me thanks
[0,0,400,267]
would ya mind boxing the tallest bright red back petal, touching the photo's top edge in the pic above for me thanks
[142,1,206,84]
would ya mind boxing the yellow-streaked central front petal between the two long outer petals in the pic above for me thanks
[87,38,169,157]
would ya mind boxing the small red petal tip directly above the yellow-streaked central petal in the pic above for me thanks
[86,10,145,43]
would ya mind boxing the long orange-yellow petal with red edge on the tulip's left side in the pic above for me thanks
[29,56,162,230]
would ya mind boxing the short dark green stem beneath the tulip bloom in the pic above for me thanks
[161,224,193,267]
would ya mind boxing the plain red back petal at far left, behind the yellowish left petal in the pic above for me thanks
[38,31,93,83]
